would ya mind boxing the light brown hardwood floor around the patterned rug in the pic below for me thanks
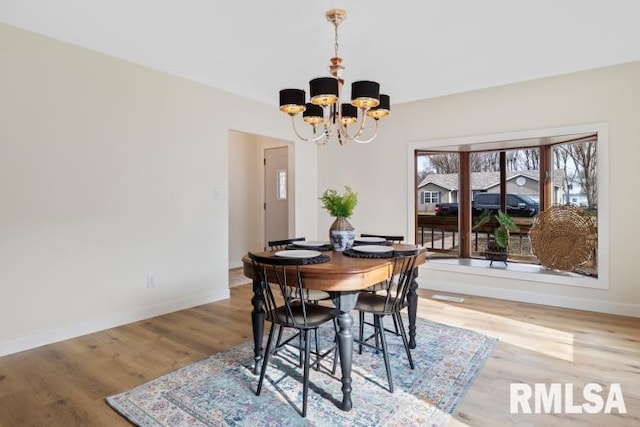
[0,285,640,427]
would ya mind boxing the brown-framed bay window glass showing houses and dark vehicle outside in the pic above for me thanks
[415,135,598,276]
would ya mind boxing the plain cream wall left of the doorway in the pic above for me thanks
[0,24,317,355]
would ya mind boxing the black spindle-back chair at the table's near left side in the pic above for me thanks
[248,253,338,417]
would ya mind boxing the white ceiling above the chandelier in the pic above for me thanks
[0,0,640,105]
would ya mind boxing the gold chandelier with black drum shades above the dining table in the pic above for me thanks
[280,9,391,145]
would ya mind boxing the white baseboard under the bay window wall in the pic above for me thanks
[417,277,640,317]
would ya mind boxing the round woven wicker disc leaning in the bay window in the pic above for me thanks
[529,205,597,271]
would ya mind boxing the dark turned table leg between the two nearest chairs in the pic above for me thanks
[333,292,358,411]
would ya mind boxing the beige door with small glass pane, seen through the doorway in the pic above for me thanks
[264,147,290,247]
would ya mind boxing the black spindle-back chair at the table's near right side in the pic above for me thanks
[355,248,419,393]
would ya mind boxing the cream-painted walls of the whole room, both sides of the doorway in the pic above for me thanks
[0,19,640,355]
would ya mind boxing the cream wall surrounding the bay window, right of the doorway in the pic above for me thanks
[318,62,640,317]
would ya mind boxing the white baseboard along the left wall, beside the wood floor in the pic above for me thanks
[0,289,229,357]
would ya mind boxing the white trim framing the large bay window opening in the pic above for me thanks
[407,123,611,289]
